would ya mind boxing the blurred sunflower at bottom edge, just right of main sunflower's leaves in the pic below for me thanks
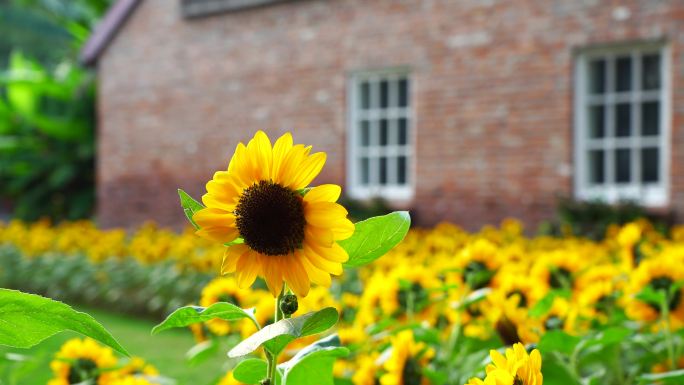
[380,330,434,385]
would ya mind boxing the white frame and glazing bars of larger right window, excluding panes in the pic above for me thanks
[574,42,672,207]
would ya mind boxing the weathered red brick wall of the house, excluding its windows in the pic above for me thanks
[92,0,684,228]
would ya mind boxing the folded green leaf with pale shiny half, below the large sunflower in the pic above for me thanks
[228,307,339,358]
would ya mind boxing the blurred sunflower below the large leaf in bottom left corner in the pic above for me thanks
[49,338,116,385]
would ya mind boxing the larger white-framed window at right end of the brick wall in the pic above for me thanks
[575,45,670,206]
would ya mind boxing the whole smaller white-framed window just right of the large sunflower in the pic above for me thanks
[347,70,413,200]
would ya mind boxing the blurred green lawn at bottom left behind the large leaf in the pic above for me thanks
[0,308,227,385]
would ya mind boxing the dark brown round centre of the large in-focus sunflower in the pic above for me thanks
[235,181,306,255]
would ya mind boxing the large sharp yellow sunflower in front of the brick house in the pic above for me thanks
[193,131,354,297]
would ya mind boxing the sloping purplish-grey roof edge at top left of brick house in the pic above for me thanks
[79,0,142,66]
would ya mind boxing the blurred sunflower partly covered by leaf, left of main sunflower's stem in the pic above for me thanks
[200,277,247,336]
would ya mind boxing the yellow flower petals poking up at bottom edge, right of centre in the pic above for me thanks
[484,343,543,385]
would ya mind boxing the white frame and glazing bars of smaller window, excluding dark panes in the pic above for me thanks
[347,68,416,201]
